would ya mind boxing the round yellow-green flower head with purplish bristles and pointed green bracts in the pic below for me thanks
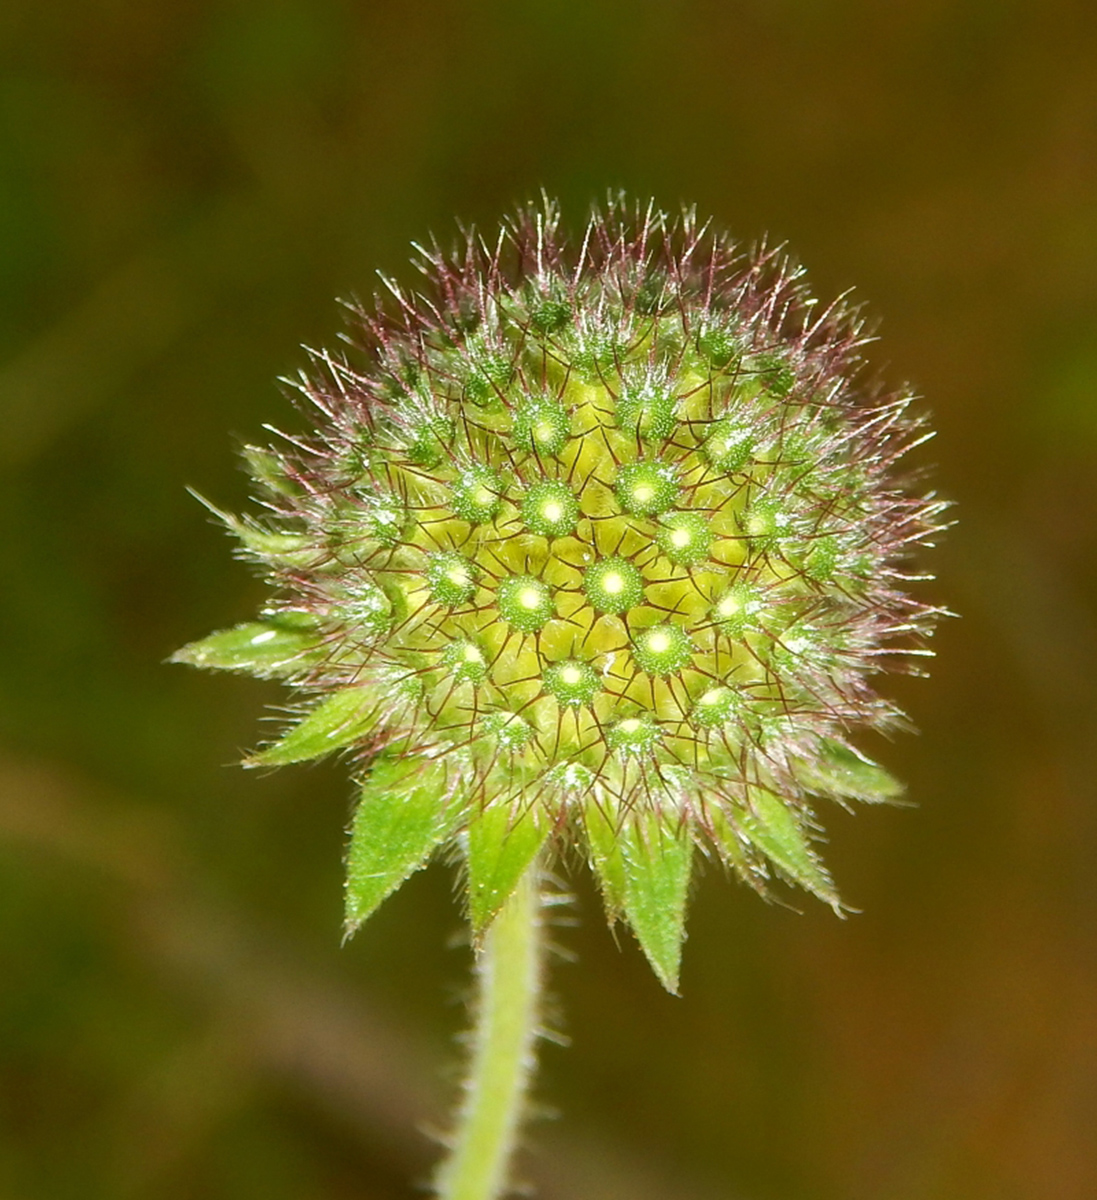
[179,200,940,988]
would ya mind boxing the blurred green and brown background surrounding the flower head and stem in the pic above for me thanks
[0,0,1097,1200]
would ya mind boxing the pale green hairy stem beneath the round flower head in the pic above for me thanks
[437,863,542,1200]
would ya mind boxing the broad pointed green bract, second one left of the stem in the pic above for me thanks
[346,758,463,935]
